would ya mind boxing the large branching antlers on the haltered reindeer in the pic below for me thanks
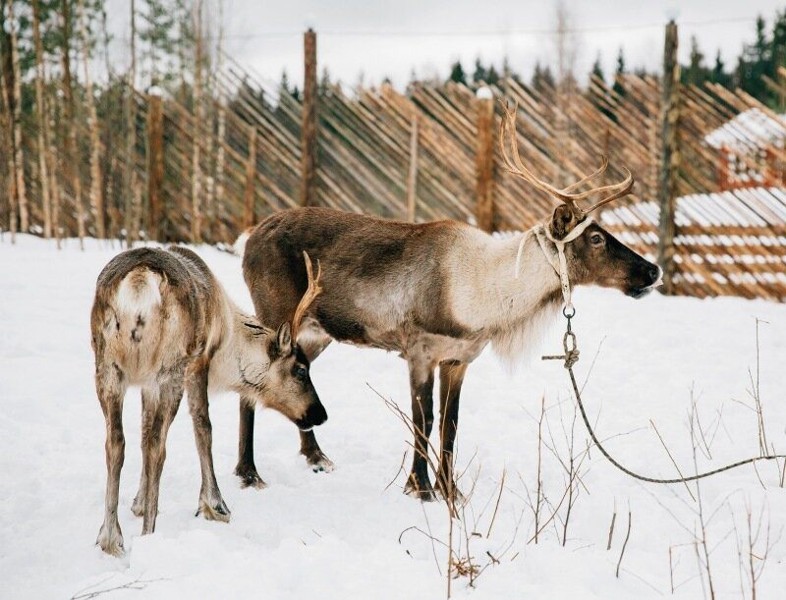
[499,105,633,217]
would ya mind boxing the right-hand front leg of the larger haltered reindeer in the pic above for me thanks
[437,361,469,502]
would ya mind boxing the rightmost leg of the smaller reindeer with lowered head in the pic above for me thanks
[186,365,230,522]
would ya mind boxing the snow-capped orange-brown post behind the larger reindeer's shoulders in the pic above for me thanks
[475,87,495,232]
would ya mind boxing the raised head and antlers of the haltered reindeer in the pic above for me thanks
[500,107,661,298]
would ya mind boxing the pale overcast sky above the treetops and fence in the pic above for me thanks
[110,0,786,87]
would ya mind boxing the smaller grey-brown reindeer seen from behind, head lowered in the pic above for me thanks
[90,246,327,556]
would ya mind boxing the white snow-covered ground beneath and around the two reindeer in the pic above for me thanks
[0,236,786,600]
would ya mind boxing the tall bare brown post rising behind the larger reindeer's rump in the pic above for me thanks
[300,29,317,206]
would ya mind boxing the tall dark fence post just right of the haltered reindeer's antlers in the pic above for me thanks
[658,20,680,294]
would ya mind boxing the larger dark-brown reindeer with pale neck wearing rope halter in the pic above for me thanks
[236,106,660,500]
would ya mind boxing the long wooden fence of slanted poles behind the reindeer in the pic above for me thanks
[0,27,786,301]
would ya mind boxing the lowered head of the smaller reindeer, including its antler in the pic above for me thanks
[241,252,327,431]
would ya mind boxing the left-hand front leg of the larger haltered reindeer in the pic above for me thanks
[404,359,436,501]
